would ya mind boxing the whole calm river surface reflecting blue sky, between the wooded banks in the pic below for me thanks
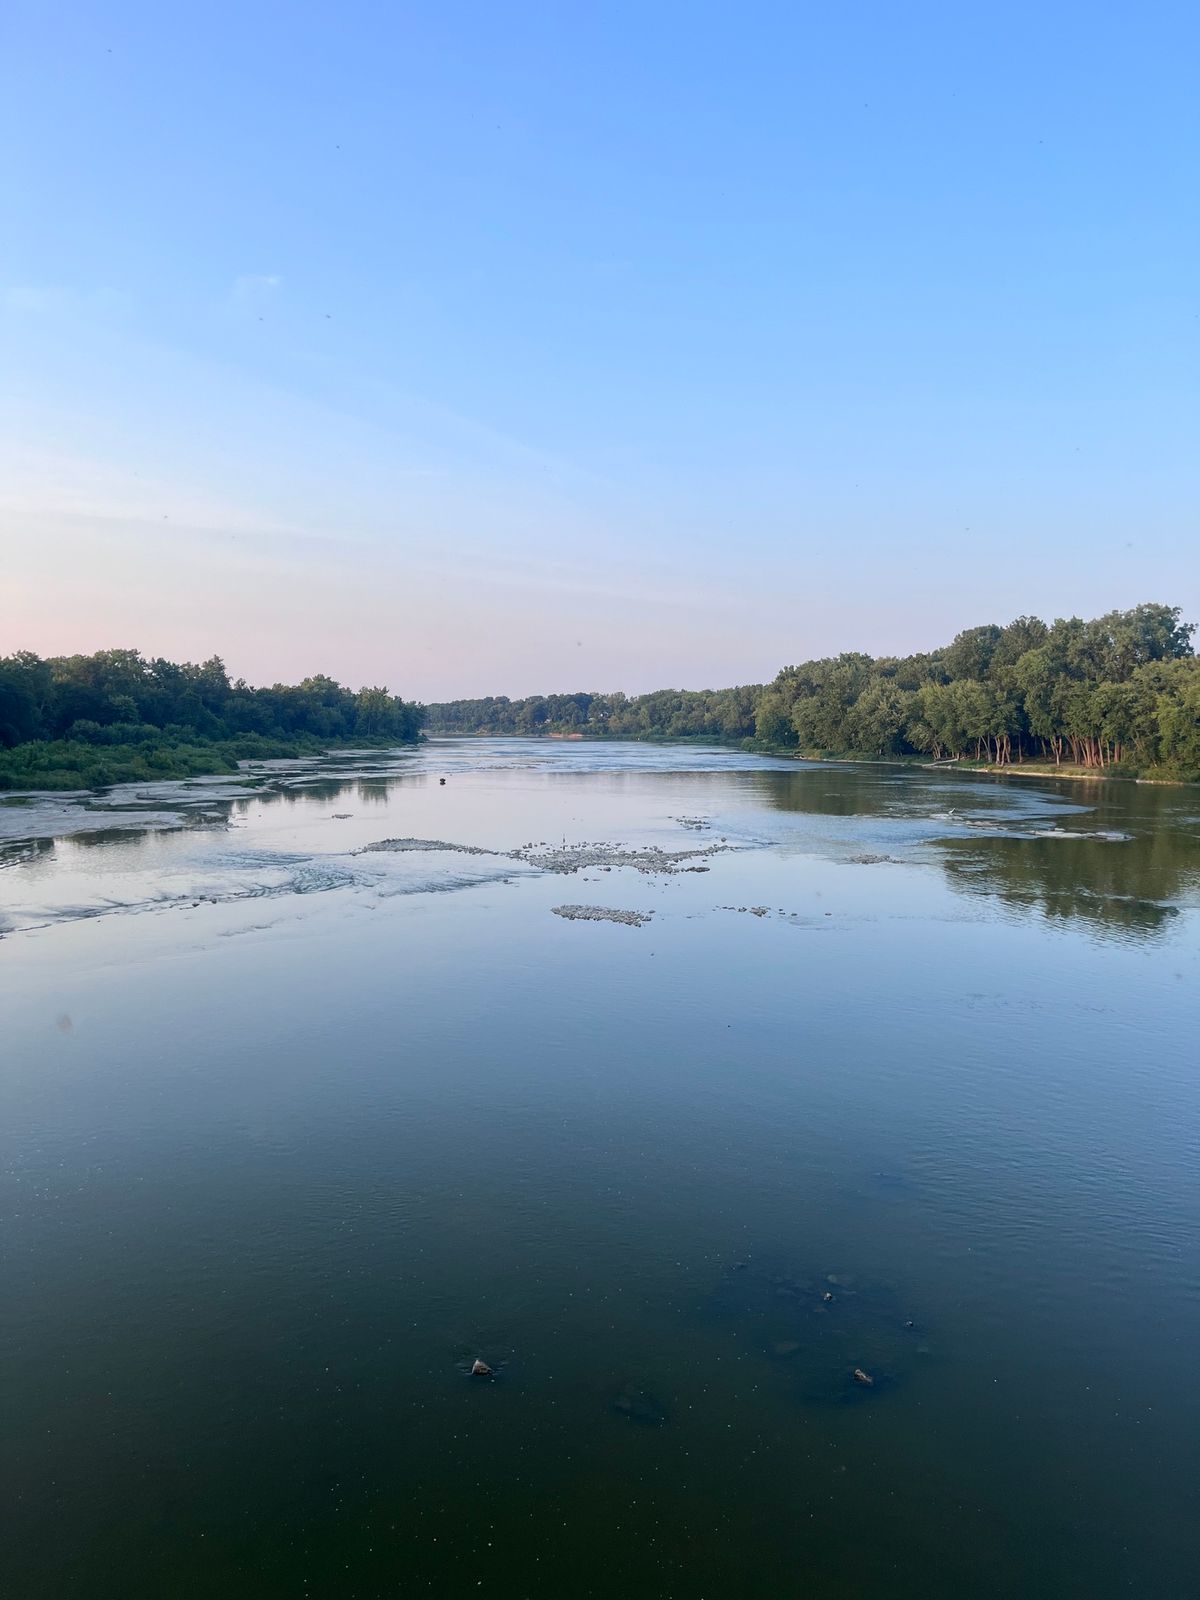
[0,741,1200,1600]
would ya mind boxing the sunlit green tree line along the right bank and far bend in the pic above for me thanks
[429,605,1200,776]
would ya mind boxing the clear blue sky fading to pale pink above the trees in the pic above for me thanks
[0,0,1200,699]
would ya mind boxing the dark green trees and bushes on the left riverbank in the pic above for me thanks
[0,650,424,787]
